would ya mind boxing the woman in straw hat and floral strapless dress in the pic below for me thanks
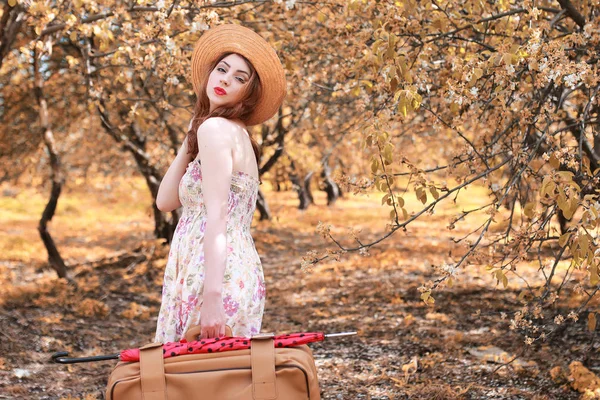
[155,25,285,343]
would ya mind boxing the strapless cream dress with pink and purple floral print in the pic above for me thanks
[155,160,265,343]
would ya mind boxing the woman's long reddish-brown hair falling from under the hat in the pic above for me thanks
[187,53,262,165]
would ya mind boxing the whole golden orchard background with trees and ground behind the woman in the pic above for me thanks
[0,0,600,399]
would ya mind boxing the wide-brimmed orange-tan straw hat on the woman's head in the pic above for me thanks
[192,24,286,126]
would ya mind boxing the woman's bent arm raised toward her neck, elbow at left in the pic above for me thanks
[156,124,191,212]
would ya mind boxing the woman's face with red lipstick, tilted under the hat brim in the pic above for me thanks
[206,54,250,111]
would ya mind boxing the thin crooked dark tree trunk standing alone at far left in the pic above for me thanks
[33,46,67,278]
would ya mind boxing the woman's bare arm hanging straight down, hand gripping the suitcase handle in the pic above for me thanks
[198,118,239,337]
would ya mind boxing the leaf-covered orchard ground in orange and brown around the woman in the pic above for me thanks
[0,182,600,400]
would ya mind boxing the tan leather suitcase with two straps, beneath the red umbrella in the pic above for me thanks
[106,334,320,400]
